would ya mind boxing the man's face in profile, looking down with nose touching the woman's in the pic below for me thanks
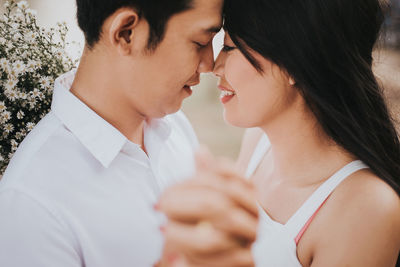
[118,0,223,118]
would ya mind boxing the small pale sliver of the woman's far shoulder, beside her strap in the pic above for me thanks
[236,128,264,173]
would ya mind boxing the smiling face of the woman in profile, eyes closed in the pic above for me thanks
[214,33,304,128]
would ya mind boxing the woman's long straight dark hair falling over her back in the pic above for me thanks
[224,0,400,195]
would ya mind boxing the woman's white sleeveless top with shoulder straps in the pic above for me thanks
[246,134,368,267]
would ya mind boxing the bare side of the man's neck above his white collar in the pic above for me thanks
[71,51,145,148]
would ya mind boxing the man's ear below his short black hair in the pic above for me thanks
[108,8,139,55]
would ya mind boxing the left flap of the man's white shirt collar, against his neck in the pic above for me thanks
[51,71,127,168]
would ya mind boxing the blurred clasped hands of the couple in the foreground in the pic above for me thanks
[157,151,258,267]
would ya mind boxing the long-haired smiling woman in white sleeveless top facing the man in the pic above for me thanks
[161,0,400,266]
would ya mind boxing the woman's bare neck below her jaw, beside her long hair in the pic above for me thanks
[261,110,354,186]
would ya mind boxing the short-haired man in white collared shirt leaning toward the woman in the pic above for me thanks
[0,0,222,267]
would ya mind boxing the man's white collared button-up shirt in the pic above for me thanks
[0,72,198,267]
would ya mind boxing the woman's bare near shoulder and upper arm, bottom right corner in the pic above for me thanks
[310,169,400,266]
